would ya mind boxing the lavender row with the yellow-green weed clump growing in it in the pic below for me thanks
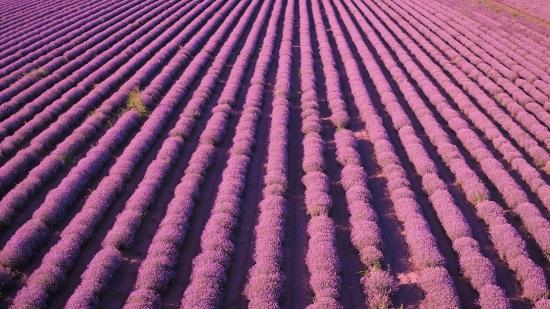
[0,0,232,276]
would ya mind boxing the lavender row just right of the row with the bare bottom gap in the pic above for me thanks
[314,0,466,308]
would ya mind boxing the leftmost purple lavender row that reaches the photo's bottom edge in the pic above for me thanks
[14,3,249,304]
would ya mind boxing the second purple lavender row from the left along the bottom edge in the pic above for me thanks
[66,3,267,308]
